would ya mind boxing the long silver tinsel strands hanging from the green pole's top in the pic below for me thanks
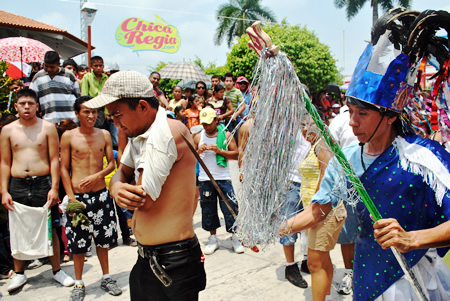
[236,54,305,248]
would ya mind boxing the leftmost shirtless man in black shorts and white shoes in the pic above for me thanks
[0,89,74,292]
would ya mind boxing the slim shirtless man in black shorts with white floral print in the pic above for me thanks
[61,96,122,301]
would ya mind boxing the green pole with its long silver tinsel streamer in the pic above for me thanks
[235,47,427,300]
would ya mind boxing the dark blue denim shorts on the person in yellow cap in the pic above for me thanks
[198,180,238,233]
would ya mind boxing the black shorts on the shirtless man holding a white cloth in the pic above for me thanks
[9,175,60,228]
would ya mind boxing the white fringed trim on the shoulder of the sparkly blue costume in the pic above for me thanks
[393,137,450,206]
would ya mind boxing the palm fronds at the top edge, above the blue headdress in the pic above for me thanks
[334,0,411,25]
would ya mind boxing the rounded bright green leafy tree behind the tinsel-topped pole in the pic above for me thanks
[227,22,342,92]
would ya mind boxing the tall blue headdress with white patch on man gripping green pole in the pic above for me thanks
[347,8,419,112]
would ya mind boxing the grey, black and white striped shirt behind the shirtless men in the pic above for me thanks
[30,68,80,123]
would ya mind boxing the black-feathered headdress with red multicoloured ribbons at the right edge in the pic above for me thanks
[405,10,450,144]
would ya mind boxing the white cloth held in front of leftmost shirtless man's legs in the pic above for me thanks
[9,202,53,260]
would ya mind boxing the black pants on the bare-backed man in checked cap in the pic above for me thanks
[130,236,206,301]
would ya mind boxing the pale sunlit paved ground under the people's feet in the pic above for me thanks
[0,162,351,301]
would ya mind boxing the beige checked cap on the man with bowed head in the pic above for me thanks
[84,71,155,109]
